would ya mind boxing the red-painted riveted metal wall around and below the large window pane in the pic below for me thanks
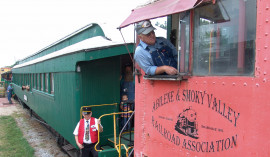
[132,0,270,157]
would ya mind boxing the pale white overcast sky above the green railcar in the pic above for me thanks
[0,0,150,67]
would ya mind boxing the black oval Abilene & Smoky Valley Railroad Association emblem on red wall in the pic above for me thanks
[152,89,240,153]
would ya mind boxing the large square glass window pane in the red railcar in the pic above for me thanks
[193,0,256,75]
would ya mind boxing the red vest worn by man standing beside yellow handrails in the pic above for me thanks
[78,117,98,144]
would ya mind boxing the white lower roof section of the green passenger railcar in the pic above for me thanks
[13,36,133,69]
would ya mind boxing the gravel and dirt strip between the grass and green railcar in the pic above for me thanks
[0,98,68,157]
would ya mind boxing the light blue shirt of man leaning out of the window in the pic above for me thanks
[134,37,177,75]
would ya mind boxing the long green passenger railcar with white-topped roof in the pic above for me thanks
[12,24,133,156]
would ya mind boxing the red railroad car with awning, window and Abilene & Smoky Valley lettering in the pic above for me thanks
[121,0,270,157]
